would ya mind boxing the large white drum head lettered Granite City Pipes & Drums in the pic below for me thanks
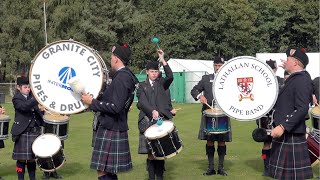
[29,40,104,114]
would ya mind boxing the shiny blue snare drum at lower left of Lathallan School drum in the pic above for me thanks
[202,108,230,134]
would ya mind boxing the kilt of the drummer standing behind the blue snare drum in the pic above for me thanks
[198,115,232,142]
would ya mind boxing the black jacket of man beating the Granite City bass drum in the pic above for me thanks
[90,68,138,131]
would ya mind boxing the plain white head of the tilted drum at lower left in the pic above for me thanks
[32,134,61,158]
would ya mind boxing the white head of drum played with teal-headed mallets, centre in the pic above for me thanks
[144,121,174,140]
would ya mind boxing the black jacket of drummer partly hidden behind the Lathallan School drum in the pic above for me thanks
[191,74,214,111]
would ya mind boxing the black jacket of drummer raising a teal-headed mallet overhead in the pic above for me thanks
[137,65,173,120]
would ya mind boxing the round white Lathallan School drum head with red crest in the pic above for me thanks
[212,56,279,121]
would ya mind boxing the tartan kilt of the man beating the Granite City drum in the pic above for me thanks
[90,126,132,174]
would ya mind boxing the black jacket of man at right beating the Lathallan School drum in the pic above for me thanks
[274,71,313,133]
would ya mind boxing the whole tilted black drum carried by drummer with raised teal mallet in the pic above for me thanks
[144,121,183,160]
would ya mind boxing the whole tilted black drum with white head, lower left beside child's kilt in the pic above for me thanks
[32,134,65,172]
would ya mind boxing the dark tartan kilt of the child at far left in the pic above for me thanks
[12,131,41,160]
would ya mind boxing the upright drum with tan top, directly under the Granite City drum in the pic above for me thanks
[42,114,69,140]
